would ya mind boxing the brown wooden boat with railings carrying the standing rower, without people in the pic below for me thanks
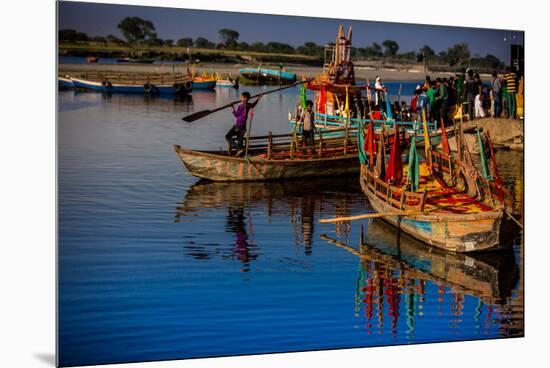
[174,128,358,181]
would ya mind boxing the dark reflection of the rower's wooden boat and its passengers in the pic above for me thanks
[174,177,368,271]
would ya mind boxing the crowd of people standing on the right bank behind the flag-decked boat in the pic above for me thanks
[373,68,523,123]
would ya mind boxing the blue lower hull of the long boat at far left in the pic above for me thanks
[72,78,192,95]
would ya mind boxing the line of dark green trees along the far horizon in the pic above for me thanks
[59,17,504,69]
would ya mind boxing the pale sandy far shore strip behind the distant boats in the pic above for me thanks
[59,63,474,82]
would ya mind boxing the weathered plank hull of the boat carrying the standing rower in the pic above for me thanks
[174,145,359,181]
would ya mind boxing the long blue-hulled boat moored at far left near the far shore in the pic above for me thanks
[67,73,193,95]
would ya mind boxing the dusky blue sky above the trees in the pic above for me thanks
[58,2,524,62]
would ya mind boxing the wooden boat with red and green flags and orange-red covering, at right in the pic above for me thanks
[359,121,511,252]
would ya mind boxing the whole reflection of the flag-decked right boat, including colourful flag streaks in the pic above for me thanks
[321,219,523,339]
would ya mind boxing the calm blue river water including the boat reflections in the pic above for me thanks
[58,84,523,366]
